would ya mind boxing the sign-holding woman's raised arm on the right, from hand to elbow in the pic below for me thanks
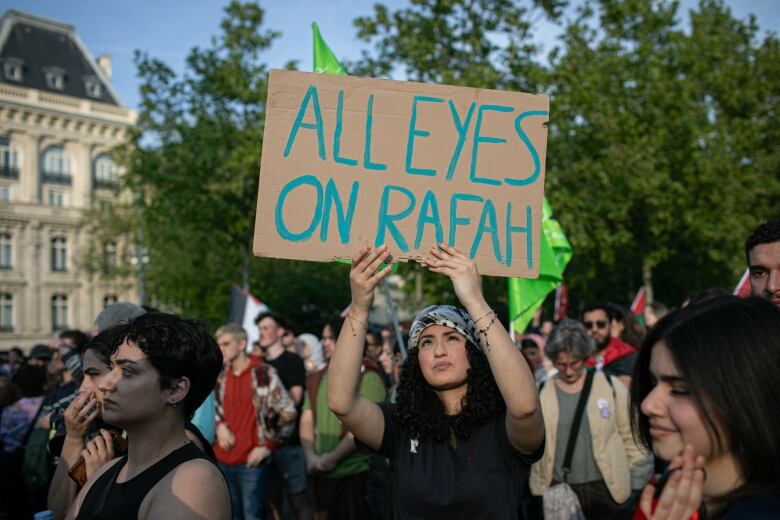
[423,244,544,453]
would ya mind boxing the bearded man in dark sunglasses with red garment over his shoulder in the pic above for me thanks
[582,303,636,387]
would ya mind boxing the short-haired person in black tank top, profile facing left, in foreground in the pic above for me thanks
[68,313,230,519]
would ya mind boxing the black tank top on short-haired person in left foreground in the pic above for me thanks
[76,442,213,520]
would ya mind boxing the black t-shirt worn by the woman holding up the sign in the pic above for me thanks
[356,403,544,520]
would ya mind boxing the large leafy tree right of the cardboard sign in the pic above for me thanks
[547,0,780,303]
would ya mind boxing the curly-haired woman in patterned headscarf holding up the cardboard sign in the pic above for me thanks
[328,244,544,518]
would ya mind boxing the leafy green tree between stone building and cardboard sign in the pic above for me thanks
[96,1,349,331]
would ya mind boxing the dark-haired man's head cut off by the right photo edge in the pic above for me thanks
[745,218,780,307]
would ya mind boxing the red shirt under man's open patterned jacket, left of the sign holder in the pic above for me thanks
[214,357,261,466]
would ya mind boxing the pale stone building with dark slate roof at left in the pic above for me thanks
[0,11,138,350]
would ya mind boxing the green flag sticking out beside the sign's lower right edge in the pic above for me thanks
[509,198,572,332]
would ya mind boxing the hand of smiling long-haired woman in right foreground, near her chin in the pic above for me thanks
[639,444,704,520]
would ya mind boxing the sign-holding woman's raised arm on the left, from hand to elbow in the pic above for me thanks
[328,246,391,449]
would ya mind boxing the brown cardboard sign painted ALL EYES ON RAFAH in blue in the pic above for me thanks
[253,70,549,278]
